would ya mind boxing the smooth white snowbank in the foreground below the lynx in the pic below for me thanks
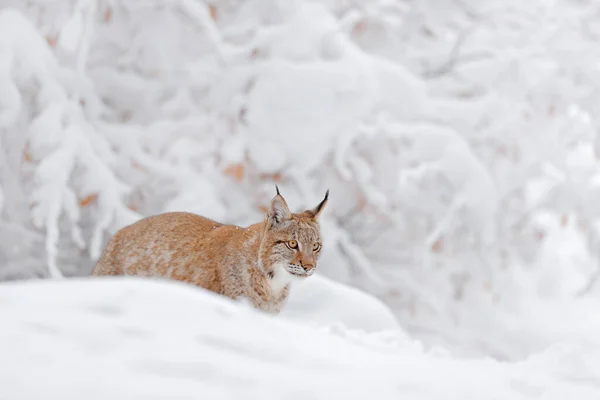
[0,278,600,400]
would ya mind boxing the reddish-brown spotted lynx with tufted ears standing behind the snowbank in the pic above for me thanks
[92,187,329,313]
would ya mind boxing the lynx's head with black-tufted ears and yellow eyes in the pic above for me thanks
[259,188,329,278]
